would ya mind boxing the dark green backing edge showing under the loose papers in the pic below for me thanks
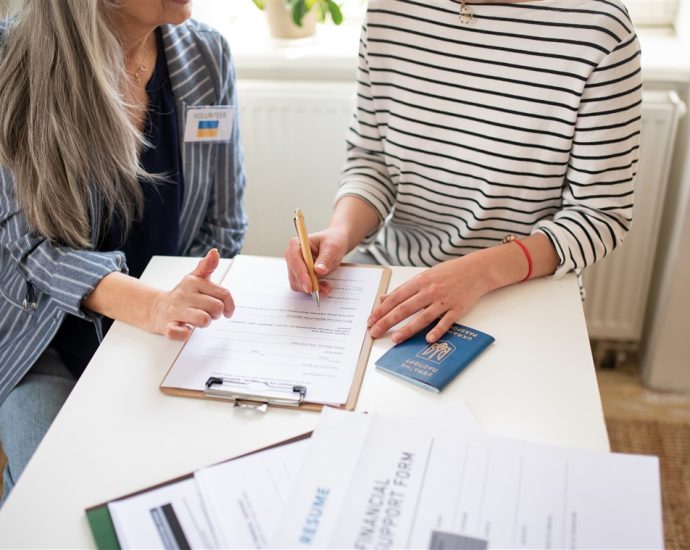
[86,432,312,550]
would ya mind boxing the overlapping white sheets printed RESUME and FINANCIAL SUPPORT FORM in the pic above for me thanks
[271,408,664,550]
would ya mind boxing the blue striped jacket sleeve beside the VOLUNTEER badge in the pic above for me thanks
[186,33,247,258]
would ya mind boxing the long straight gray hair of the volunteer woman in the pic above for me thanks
[0,0,147,248]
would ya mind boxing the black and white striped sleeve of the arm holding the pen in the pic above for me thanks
[336,24,396,238]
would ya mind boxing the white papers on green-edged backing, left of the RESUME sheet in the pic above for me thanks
[105,439,309,549]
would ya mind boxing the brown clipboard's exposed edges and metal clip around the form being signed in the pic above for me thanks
[159,263,391,412]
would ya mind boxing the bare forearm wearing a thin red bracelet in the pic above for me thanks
[468,233,559,292]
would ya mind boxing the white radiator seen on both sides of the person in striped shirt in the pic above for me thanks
[238,80,683,341]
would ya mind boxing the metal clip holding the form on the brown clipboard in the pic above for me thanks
[204,376,307,412]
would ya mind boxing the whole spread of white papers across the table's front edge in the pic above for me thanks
[97,404,663,549]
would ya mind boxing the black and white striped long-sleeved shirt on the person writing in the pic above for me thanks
[338,0,641,275]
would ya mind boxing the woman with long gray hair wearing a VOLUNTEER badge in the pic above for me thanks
[0,0,246,497]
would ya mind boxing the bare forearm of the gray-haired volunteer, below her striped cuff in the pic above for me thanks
[83,272,162,330]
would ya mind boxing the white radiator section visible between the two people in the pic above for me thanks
[237,80,355,256]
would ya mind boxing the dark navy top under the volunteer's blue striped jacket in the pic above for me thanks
[51,29,184,378]
